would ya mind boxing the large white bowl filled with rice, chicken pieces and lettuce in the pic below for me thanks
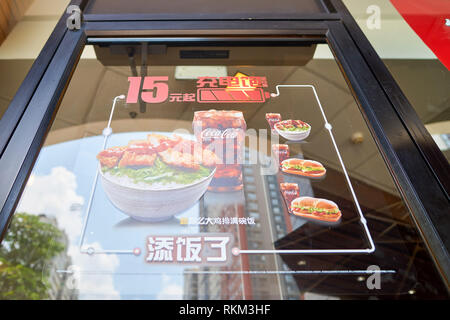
[97,134,219,222]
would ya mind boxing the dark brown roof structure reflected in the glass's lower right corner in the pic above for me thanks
[275,168,446,299]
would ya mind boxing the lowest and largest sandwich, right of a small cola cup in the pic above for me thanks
[291,197,342,222]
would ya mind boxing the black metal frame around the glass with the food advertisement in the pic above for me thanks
[0,0,450,285]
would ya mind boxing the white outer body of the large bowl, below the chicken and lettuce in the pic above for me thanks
[99,169,216,222]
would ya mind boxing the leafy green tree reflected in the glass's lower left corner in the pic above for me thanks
[0,213,65,299]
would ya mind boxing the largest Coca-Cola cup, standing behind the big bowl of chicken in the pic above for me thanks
[192,110,247,192]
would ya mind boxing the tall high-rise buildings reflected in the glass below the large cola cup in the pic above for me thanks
[184,150,299,300]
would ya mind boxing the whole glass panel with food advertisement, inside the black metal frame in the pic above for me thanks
[0,40,446,299]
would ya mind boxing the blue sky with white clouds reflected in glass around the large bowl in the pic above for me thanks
[21,132,313,299]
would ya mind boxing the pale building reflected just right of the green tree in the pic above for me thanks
[39,214,77,300]
